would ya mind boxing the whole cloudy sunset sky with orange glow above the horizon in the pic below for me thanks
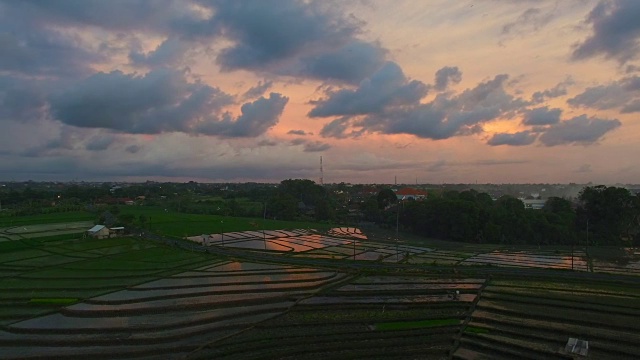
[0,0,640,184]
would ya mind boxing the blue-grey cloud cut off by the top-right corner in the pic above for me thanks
[572,0,640,63]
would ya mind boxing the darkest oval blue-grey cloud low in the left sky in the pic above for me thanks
[50,69,233,134]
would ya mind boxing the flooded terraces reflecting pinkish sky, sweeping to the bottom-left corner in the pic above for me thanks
[0,262,345,359]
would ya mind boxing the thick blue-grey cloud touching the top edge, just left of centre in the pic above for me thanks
[212,0,360,70]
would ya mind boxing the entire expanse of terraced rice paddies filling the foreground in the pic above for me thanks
[0,224,640,359]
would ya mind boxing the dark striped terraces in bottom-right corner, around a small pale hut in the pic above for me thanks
[454,280,640,359]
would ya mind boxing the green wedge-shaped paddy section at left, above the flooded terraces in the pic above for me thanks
[0,233,219,325]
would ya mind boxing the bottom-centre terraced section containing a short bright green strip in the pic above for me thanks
[189,276,485,359]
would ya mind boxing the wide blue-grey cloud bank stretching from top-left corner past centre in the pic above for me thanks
[0,0,396,86]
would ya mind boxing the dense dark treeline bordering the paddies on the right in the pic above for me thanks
[392,186,640,246]
